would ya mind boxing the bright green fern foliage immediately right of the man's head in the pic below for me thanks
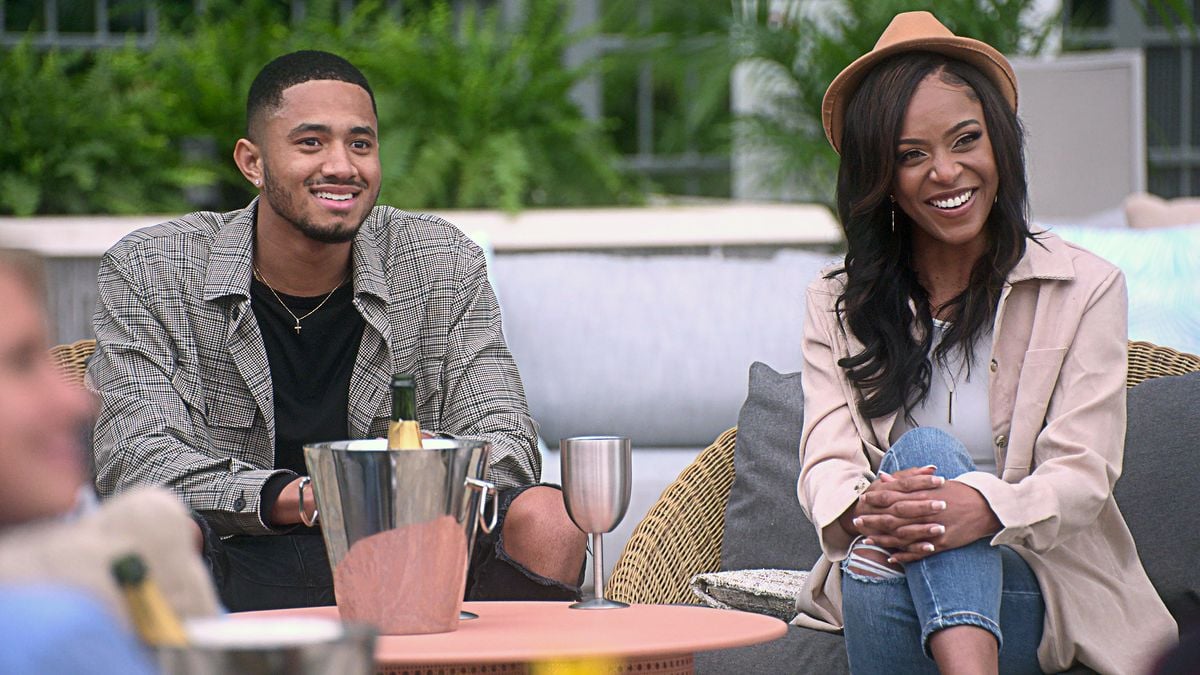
[354,0,640,211]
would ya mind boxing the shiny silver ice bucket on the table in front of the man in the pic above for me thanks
[301,438,498,635]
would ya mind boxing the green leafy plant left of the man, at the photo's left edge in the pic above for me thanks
[0,43,212,216]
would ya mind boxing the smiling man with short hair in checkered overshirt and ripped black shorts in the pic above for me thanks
[88,52,586,610]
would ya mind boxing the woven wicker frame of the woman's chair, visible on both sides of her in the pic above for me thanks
[607,342,1200,604]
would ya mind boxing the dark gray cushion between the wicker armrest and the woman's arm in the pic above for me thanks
[721,362,821,569]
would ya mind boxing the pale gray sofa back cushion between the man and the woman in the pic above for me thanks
[492,251,829,448]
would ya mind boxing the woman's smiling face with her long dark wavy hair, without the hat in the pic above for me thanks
[829,43,1031,414]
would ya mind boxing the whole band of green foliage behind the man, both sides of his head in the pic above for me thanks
[0,0,641,215]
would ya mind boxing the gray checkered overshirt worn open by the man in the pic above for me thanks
[88,199,541,534]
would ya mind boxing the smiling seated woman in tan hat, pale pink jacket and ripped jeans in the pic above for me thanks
[798,12,1183,673]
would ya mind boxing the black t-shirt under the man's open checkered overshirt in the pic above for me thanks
[250,273,366,473]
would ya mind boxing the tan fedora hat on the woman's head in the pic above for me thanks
[821,12,1016,153]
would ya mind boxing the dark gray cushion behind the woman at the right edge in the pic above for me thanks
[1114,372,1200,623]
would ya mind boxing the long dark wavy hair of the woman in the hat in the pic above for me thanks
[829,52,1033,420]
